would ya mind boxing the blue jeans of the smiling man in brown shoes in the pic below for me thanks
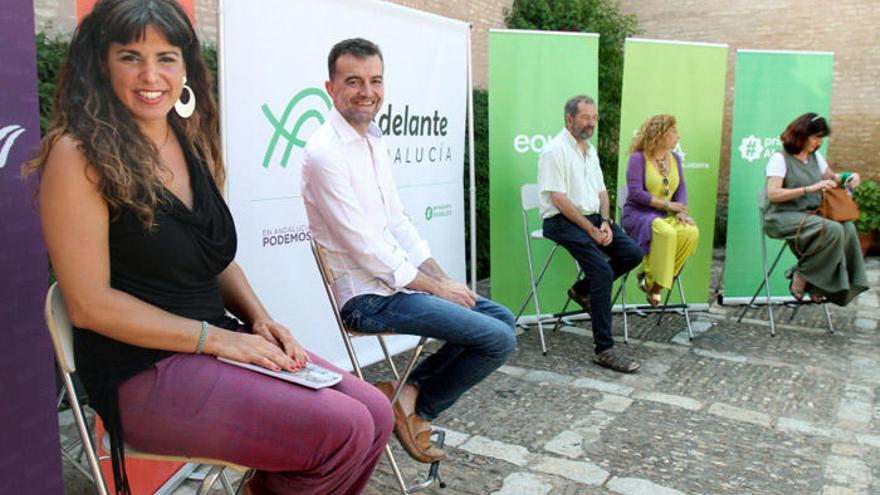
[341,292,516,421]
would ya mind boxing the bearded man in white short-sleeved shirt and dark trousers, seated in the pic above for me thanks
[538,95,642,373]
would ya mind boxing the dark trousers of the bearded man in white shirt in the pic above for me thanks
[544,214,643,352]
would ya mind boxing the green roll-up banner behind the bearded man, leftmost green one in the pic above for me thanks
[489,30,602,314]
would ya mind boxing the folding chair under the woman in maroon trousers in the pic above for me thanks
[45,282,248,495]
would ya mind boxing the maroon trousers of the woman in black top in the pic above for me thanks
[119,354,394,495]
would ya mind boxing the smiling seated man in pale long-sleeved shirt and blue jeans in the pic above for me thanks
[301,39,516,462]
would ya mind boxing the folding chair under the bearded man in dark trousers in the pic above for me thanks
[516,184,585,356]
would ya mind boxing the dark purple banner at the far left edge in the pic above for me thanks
[0,0,64,494]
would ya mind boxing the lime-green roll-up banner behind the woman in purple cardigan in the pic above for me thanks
[617,39,727,304]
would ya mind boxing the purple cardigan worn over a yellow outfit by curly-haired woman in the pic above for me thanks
[620,151,687,255]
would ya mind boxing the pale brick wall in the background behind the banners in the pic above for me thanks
[34,0,868,187]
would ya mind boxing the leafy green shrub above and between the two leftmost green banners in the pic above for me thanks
[505,0,640,204]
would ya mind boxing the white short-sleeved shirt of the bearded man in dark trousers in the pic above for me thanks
[538,128,605,218]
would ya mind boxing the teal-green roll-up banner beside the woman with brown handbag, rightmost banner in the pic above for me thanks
[724,50,834,303]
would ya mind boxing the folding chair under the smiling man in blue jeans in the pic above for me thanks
[310,238,446,494]
